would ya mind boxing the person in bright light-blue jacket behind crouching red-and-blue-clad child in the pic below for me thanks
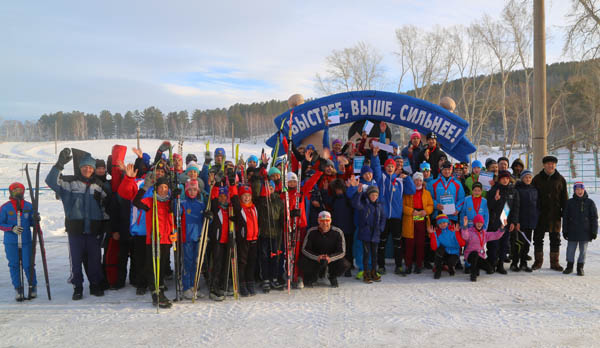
[430,161,465,224]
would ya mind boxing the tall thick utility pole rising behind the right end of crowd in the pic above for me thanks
[533,0,548,173]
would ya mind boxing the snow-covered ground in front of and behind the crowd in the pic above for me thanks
[0,140,600,347]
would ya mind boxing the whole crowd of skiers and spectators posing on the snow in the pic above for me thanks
[0,120,598,308]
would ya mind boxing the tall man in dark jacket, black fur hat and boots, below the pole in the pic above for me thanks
[531,156,568,271]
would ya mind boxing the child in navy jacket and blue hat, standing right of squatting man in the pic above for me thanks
[349,178,385,284]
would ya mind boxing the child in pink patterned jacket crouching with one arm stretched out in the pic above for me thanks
[461,214,505,282]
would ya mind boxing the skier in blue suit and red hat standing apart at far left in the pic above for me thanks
[0,182,39,302]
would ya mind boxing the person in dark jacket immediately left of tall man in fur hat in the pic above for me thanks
[510,170,540,272]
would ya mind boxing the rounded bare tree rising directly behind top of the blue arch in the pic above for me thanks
[316,41,385,95]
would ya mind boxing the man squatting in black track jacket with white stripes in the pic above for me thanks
[299,210,350,288]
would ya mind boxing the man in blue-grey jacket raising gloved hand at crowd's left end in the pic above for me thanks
[46,148,110,301]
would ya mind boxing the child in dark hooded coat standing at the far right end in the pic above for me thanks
[563,182,598,276]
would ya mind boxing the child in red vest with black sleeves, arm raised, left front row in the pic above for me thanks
[133,174,173,308]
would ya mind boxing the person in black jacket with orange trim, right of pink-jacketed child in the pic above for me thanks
[487,170,519,274]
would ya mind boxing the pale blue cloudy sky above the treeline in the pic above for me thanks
[0,0,570,120]
